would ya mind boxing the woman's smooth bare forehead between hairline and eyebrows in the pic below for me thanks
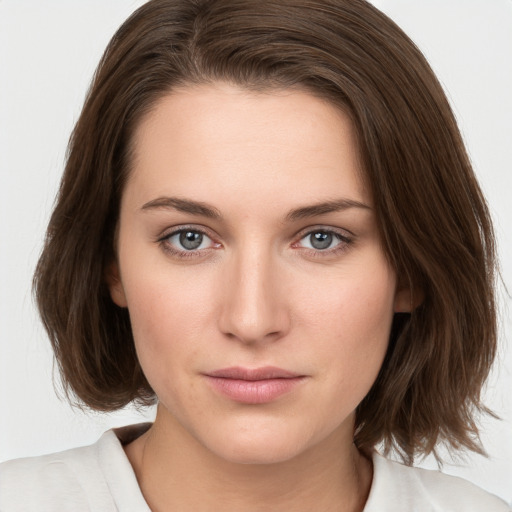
[129,83,369,211]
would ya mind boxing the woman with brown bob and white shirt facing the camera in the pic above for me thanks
[0,0,507,512]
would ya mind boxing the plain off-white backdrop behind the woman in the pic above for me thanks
[0,0,512,502]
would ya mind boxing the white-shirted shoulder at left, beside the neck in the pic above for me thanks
[0,430,148,512]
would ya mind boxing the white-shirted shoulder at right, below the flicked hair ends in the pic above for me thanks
[364,453,511,512]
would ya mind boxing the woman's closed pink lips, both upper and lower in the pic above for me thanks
[205,366,306,404]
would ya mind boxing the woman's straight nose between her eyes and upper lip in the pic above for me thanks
[219,244,290,344]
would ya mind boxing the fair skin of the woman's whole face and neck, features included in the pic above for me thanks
[109,83,410,512]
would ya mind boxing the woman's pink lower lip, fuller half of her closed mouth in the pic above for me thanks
[207,376,304,404]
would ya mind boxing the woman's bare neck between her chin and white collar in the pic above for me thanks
[125,414,372,512]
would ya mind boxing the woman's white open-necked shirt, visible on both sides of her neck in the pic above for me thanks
[0,424,512,512]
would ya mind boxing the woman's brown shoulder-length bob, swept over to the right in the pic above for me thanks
[34,0,496,463]
